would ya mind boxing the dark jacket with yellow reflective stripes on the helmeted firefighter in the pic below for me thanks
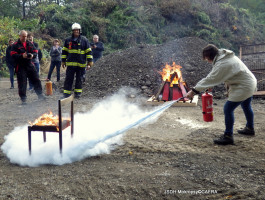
[62,36,93,67]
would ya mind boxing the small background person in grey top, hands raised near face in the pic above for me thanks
[46,39,62,81]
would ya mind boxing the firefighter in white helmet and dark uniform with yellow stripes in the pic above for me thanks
[62,23,93,98]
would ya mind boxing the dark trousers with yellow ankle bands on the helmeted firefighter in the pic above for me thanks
[64,66,85,95]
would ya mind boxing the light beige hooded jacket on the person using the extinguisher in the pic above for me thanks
[194,49,257,102]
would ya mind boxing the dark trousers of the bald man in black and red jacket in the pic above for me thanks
[17,64,42,99]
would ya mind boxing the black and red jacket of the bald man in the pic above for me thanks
[11,39,38,71]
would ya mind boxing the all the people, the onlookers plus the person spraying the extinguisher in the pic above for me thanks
[7,23,257,145]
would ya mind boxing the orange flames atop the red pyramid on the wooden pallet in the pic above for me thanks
[159,62,184,85]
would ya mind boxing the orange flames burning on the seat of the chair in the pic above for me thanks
[29,111,59,126]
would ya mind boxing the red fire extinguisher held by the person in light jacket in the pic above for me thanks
[202,91,213,122]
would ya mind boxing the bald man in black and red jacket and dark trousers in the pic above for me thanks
[11,30,45,104]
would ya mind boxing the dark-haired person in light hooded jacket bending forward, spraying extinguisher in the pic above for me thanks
[187,44,257,145]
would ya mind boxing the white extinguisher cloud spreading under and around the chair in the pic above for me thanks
[1,90,174,167]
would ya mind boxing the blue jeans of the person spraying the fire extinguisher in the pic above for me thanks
[224,97,254,136]
